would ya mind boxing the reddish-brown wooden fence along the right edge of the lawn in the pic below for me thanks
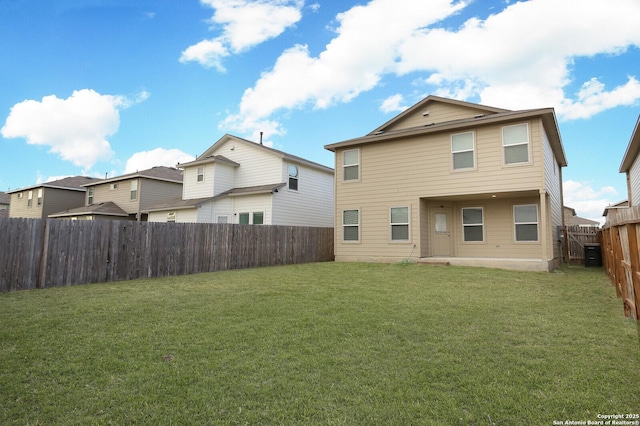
[602,207,640,320]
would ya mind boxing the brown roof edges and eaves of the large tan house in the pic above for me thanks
[325,96,567,167]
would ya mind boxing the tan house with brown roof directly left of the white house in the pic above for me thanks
[49,166,182,221]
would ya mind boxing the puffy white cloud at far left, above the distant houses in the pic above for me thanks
[0,89,149,169]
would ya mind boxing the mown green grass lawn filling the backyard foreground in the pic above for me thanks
[0,263,640,425]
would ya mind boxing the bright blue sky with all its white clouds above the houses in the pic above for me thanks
[0,0,640,220]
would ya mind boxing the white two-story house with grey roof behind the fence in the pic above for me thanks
[147,135,333,227]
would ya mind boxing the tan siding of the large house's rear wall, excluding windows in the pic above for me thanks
[334,120,546,260]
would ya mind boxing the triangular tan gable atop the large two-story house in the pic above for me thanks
[369,96,509,135]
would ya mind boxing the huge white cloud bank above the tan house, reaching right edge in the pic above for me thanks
[224,0,640,132]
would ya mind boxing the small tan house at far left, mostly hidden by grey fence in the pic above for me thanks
[8,176,100,219]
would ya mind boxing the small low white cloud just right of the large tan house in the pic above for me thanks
[562,180,620,223]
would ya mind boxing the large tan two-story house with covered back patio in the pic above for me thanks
[325,96,567,271]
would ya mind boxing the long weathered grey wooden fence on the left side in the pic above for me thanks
[0,218,334,292]
